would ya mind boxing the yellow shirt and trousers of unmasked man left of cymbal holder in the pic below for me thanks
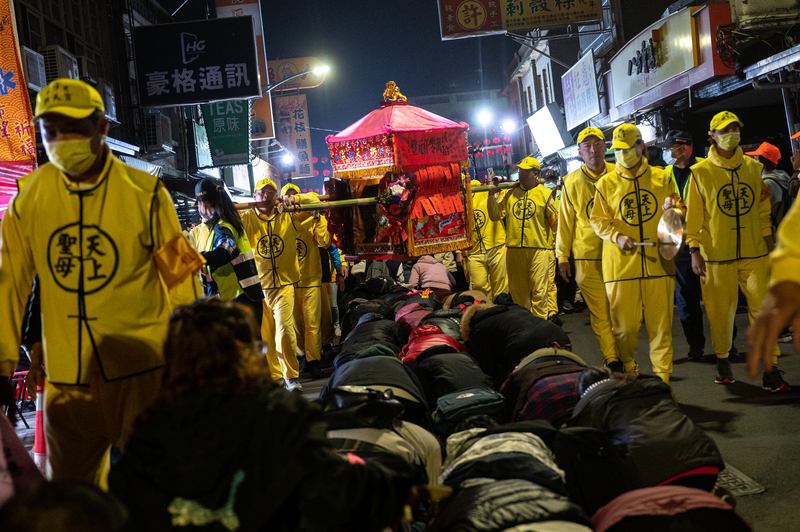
[556,163,619,364]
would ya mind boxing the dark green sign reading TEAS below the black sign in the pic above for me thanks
[201,100,250,166]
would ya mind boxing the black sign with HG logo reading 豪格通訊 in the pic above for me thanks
[133,16,261,107]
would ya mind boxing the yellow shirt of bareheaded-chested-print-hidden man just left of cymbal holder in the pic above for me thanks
[556,163,614,262]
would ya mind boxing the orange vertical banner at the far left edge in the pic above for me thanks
[0,0,36,218]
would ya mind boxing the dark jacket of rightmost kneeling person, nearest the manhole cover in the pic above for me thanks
[568,375,725,487]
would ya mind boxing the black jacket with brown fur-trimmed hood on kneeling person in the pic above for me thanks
[461,305,570,389]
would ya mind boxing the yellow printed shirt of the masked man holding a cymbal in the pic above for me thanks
[589,157,678,283]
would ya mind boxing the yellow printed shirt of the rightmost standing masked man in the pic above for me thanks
[686,146,772,262]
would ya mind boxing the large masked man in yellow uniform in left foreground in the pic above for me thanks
[0,79,201,486]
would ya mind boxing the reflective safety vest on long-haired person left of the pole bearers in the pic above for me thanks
[203,221,264,301]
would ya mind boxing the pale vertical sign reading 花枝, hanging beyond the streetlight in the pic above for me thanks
[275,94,314,178]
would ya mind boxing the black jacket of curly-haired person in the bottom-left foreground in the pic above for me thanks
[109,385,413,532]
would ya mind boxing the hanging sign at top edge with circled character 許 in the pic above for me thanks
[439,0,602,41]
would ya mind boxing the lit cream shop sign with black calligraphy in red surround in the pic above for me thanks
[611,8,698,105]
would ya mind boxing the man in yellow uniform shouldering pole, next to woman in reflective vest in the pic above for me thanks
[241,178,303,391]
